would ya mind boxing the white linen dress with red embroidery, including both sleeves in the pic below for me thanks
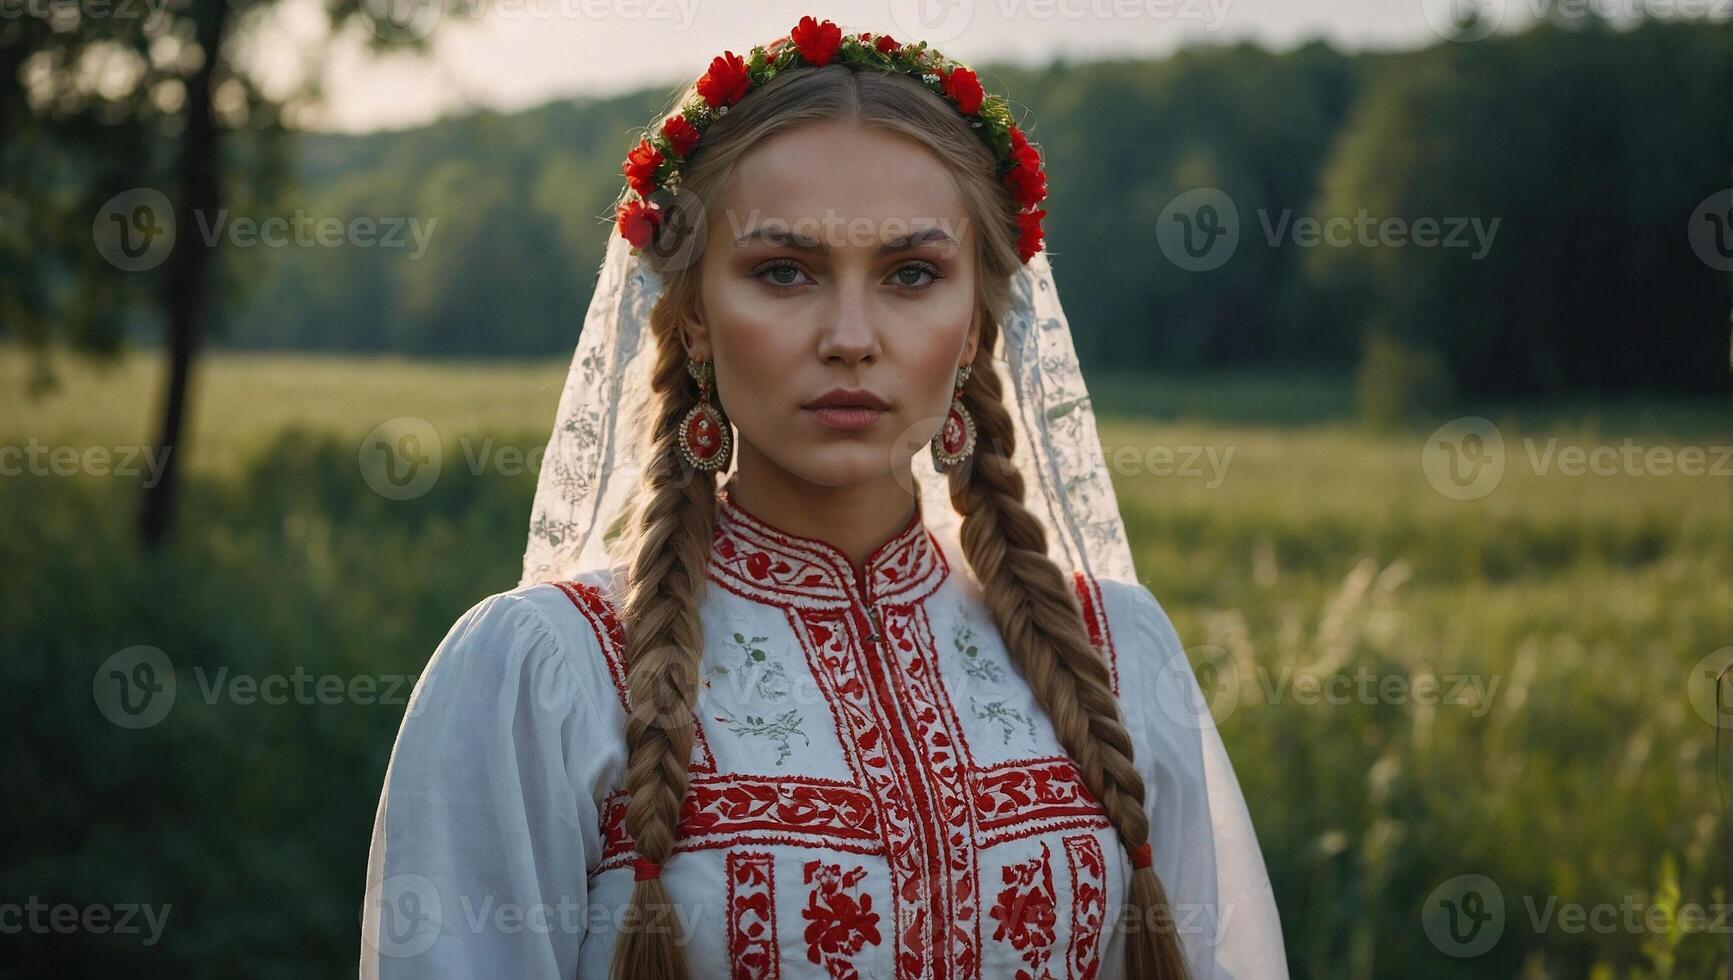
[360,487,1288,980]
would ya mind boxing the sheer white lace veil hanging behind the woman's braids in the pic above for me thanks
[520,234,1137,585]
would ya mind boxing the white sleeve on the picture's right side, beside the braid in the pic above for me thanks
[1120,583,1288,980]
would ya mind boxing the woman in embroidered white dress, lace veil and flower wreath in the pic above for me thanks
[362,17,1286,978]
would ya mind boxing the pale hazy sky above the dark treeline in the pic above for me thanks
[251,0,1635,132]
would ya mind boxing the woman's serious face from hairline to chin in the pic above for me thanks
[686,123,979,487]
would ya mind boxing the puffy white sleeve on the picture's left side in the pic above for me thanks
[360,593,594,980]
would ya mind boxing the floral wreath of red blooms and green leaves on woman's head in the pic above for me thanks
[615,17,1047,262]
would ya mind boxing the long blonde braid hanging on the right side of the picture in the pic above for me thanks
[951,319,1189,980]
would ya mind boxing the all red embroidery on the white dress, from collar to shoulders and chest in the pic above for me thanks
[567,498,1118,980]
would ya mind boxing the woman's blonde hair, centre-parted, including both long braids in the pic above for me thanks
[613,64,1187,980]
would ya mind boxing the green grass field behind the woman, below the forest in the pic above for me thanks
[0,345,1733,980]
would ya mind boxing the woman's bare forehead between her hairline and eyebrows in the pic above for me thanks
[721,121,967,234]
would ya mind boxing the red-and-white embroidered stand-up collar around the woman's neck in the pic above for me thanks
[711,484,950,609]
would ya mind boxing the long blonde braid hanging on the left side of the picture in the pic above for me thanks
[613,317,716,980]
